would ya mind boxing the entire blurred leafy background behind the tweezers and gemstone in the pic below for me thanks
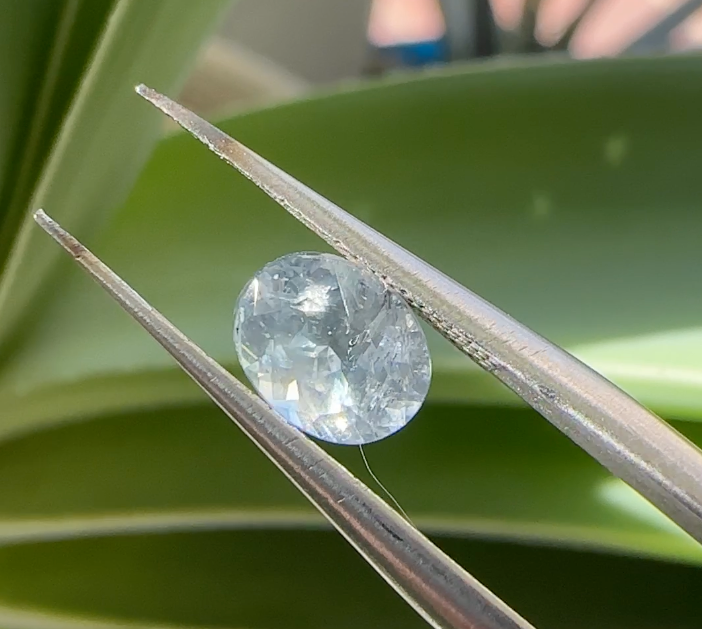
[0,0,702,629]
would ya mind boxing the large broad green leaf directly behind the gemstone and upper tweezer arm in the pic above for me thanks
[0,57,702,430]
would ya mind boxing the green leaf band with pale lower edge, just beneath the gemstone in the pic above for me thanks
[0,405,702,564]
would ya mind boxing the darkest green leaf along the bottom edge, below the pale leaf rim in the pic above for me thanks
[0,529,700,629]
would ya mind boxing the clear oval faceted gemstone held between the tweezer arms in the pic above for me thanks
[234,253,431,444]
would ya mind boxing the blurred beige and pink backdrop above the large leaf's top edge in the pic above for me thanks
[183,0,702,113]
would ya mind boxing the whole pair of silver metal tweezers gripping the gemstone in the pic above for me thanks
[35,85,702,629]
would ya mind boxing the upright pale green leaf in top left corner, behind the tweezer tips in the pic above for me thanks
[0,0,228,341]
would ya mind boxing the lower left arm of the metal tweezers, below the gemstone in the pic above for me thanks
[34,210,533,629]
